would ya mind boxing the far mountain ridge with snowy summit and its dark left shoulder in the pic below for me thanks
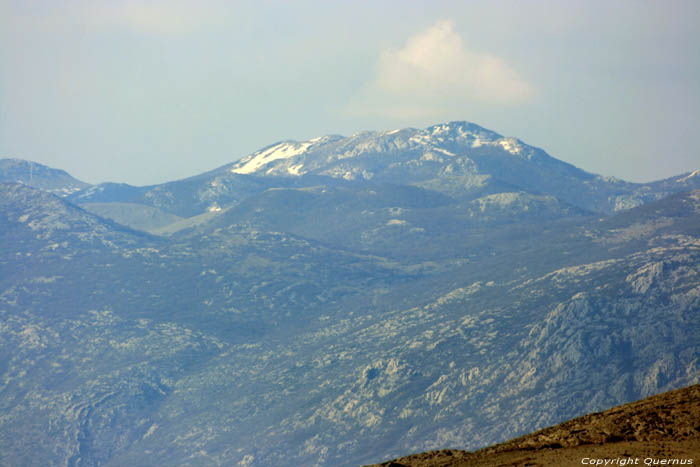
[63,122,700,236]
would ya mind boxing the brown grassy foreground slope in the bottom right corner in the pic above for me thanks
[374,385,700,467]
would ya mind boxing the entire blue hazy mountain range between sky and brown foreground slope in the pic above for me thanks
[0,122,700,466]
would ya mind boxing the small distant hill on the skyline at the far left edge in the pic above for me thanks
[0,159,90,196]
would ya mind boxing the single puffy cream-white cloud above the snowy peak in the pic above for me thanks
[348,21,533,117]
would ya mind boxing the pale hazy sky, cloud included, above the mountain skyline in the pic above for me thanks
[0,0,700,185]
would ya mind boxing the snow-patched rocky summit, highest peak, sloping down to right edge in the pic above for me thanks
[227,122,700,212]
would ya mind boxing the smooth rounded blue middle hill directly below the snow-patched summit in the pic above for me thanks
[198,183,591,261]
